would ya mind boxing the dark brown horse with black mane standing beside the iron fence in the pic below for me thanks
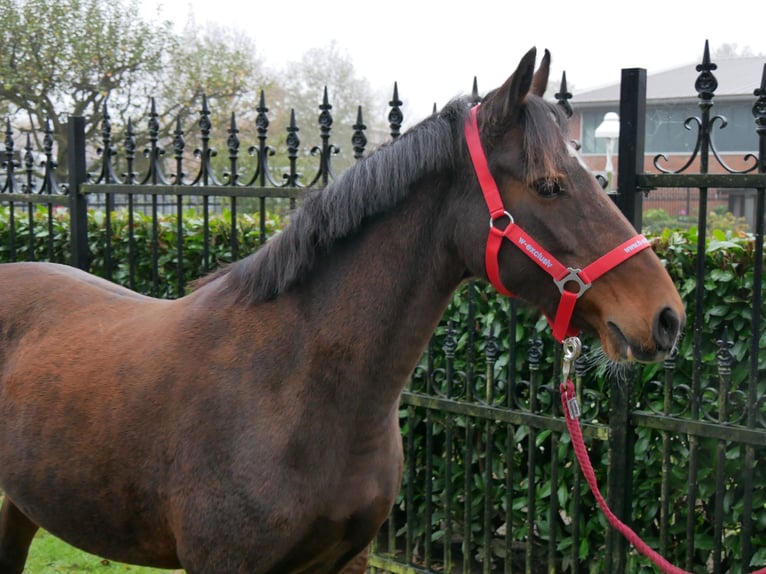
[0,49,684,574]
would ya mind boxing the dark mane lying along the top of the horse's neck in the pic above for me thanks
[212,99,468,303]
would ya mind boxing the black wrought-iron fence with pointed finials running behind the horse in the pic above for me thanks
[0,46,766,573]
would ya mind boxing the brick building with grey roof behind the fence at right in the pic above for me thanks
[571,56,766,227]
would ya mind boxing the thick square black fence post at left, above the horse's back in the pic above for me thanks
[67,116,90,271]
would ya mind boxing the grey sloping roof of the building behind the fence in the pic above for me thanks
[572,56,766,106]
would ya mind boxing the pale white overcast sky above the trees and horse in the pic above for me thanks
[141,0,766,123]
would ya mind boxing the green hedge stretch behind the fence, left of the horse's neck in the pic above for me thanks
[0,206,284,298]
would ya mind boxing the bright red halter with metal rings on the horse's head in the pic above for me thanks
[465,105,650,342]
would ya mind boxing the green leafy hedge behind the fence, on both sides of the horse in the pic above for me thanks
[0,207,766,572]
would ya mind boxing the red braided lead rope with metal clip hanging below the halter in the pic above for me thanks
[560,338,766,574]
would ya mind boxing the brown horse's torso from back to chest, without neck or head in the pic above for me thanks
[0,264,408,572]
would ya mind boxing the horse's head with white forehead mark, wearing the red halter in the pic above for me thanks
[461,48,685,362]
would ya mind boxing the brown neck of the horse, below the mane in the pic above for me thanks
[294,184,465,418]
